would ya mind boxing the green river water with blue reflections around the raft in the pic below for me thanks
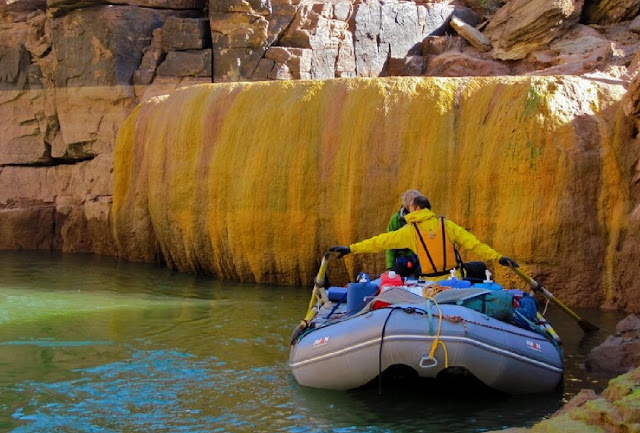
[0,252,624,433]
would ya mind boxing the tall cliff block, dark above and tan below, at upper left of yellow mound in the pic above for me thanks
[49,6,188,159]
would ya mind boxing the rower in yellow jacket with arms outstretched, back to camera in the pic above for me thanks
[329,196,518,281]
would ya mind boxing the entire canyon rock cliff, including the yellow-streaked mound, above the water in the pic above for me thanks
[0,0,640,311]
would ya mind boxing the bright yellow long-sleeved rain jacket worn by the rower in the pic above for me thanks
[349,209,502,280]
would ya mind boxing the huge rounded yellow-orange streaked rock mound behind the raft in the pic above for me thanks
[113,76,629,305]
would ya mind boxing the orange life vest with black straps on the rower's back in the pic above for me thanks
[412,217,459,277]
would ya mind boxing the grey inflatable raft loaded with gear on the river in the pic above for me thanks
[289,256,564,394]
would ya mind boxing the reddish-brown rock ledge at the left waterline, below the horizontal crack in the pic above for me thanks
[0,155,116,255]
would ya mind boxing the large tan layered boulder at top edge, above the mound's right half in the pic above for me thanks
[484,0,584,60]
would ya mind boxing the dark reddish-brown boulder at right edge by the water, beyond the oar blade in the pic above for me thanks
[585,314,640,374]
